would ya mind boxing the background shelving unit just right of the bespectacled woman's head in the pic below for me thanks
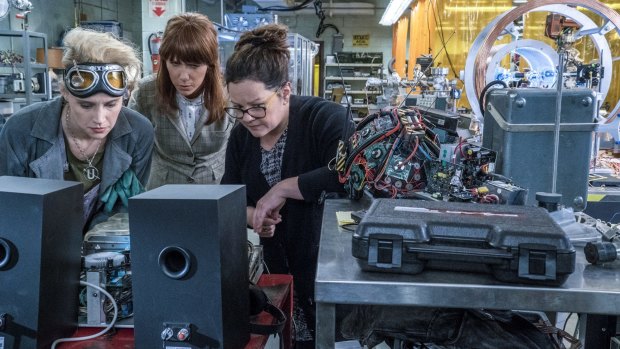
[323,62,383,118]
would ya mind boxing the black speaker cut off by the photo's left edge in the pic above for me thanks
[0,176,84,349]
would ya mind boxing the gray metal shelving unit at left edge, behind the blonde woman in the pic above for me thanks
[0,30,51,105]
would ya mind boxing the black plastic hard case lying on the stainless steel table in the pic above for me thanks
[352,199,575,286]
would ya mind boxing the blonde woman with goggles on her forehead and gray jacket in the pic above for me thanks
[0,28,153,228]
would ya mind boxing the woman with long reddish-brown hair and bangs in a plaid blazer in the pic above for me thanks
[129,13,232,189]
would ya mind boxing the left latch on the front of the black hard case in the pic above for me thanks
[368,234,403,269]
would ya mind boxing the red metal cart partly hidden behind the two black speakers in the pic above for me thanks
[56,274,293,349]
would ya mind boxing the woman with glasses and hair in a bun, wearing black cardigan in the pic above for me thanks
[222,24,348,348]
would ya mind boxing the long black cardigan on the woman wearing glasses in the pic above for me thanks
[222,95,351,297]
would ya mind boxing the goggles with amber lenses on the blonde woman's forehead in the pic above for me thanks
[65,62,127,98]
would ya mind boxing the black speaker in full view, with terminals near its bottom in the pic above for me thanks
[129,184,249,349]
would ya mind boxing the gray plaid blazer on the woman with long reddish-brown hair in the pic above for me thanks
[129,75,233,189]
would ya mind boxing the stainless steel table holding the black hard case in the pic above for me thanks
[315,199,620,349]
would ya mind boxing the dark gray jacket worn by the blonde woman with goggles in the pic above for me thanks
[0,97,153,223]
